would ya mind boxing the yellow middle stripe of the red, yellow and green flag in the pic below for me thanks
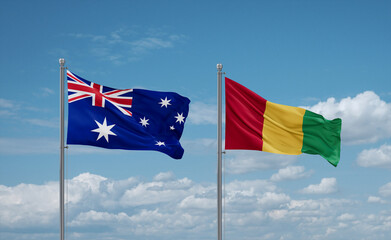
[262,101,305,155]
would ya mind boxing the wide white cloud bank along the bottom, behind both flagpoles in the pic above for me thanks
[0,172,391,240]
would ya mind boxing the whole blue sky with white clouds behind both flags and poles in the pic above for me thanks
[0,1,391,240]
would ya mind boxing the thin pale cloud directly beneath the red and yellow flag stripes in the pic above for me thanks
[226,151,296,174]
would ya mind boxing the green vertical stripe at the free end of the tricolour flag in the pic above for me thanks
[301,110,342,167]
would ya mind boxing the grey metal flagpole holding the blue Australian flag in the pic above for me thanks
[59,58,65,240]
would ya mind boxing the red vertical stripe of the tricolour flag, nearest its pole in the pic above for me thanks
[225,78,267,150]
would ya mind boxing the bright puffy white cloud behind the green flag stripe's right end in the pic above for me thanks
[306,91,391,144]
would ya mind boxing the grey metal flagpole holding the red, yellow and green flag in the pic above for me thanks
[217,63,223,240]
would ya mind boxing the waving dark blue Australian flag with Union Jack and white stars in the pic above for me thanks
[67,71,190,159]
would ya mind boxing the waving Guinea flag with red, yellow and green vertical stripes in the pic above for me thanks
[225,78,342,167]
